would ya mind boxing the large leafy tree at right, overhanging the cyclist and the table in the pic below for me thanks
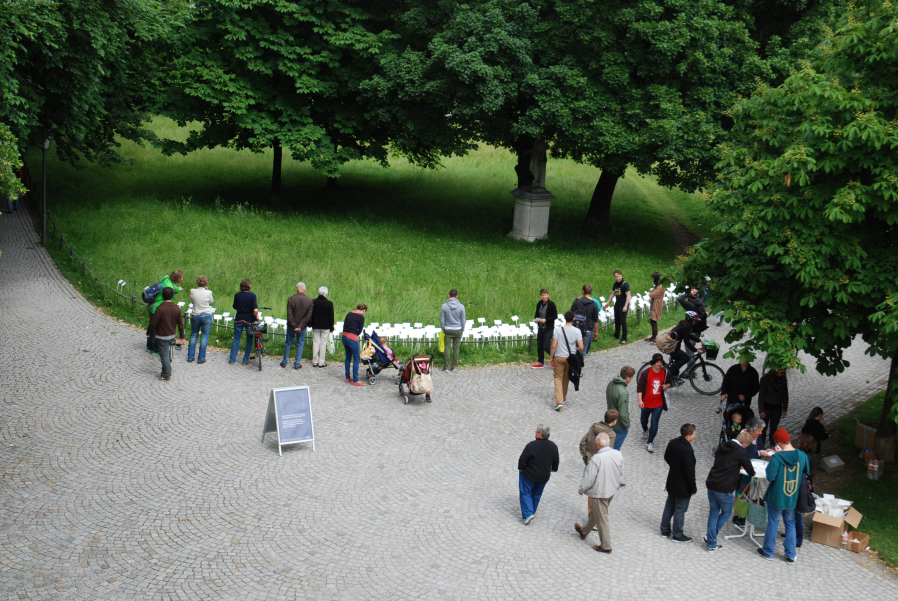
[681,2,898,458]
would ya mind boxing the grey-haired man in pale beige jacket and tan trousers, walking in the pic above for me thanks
[574,432,624,553]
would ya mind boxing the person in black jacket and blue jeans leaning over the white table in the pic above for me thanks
[704,430,755,551]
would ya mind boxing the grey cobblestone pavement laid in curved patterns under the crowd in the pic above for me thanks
[0,214,898,601]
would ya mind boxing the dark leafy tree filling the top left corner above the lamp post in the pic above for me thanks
[0,0,182,163]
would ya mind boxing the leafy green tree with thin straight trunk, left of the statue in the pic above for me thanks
[163,0,391,202]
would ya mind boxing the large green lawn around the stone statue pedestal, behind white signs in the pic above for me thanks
[29,119,708,361]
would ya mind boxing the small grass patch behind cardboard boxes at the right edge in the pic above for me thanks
[837,392,898,566]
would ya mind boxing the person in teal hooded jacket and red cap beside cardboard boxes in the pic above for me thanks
[758,428,808,565]
